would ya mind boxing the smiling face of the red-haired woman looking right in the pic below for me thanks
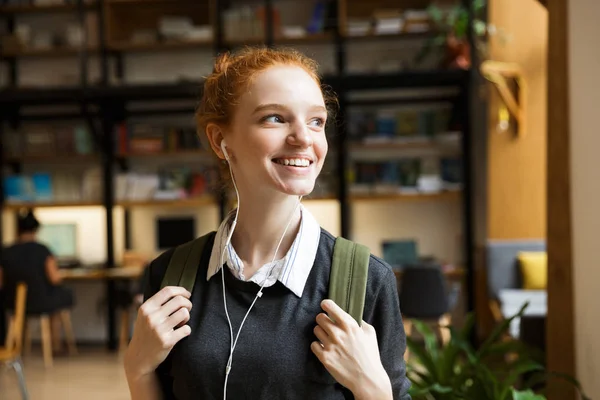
[223,66,327,199]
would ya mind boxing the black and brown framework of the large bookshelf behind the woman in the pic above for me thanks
[0,0,473,346]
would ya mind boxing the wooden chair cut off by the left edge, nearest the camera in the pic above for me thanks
[0,283,29,400]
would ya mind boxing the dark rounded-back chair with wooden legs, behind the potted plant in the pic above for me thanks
[400,264,452,360]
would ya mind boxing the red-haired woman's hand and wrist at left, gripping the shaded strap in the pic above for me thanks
[124,286,192,381]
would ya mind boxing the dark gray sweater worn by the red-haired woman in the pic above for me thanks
[144,230,410,400]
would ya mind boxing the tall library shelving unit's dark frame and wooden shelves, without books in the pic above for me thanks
[0,0,474,349]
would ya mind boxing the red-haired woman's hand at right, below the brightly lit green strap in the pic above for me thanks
[311,300,392,399]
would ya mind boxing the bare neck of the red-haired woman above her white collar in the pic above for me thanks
[231,189,301,278]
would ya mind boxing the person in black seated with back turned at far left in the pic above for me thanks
[0,210,74,350]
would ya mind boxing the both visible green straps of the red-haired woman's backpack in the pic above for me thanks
[161,232,371,325]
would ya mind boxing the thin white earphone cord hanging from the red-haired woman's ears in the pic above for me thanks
[220,140,302,400]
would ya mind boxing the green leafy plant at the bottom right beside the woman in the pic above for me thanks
[407,304,589,400]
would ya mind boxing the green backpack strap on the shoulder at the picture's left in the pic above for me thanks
[160,232,214,293]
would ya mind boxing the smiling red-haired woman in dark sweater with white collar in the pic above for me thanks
[124,48,410,400]
